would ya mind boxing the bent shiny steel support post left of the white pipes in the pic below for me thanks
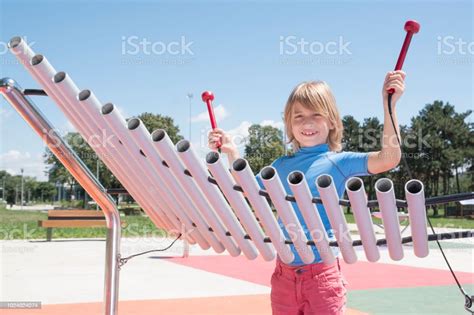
[0,79,120,315]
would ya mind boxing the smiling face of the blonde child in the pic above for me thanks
[291,103,334,147]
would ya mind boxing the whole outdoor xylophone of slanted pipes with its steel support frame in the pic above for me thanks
[0,37,473,313]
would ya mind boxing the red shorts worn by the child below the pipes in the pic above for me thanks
[271,259,347,315]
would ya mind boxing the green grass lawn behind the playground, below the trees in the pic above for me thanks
[0,207,474,240]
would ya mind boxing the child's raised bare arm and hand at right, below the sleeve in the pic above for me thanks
[368,71,405,174]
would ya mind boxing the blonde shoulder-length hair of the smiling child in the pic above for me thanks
[284,81,344,152]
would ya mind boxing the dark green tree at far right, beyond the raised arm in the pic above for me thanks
[409,101,474,215]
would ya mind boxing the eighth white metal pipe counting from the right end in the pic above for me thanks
[206,152,276,261]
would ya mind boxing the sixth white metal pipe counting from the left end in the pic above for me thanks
[127,118,210,249]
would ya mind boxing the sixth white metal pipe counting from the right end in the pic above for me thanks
[260,166,315,264]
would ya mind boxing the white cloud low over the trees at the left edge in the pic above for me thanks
[0,150,47,180]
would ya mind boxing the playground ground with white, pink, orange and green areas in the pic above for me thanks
[0,226,474,315]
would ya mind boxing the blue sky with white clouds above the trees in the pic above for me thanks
[0,0,474,179]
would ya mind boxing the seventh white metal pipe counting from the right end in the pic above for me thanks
[232,158,295,264]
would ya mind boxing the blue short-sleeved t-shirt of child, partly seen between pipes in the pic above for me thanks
[256,144,370,266]
